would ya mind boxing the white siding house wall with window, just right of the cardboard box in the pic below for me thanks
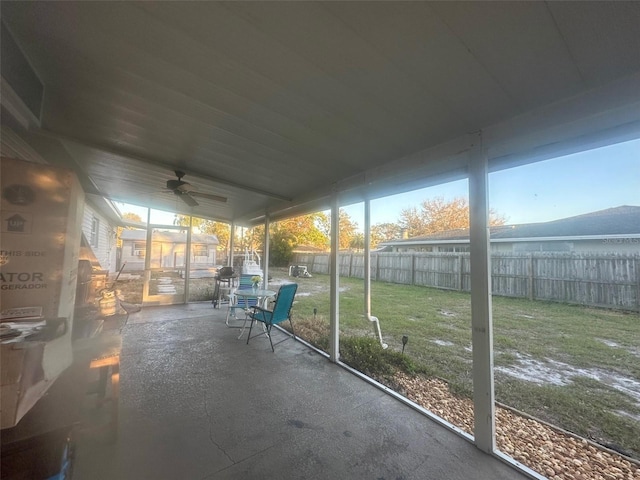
[80,197,120,273]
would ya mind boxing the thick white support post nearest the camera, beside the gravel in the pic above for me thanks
[469,138,495,453]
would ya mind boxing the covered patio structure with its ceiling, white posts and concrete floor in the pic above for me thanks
[1,2,640,478]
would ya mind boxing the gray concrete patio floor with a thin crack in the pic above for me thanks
[73,302,528,480]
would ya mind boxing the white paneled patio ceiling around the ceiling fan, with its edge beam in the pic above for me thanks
[2,1,640,224]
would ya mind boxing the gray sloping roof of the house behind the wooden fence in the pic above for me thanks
[382,205,640,245]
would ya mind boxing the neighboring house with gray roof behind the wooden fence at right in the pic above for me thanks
[379,205,640,254]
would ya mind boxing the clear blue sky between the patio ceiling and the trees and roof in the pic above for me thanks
[345,139,640,229]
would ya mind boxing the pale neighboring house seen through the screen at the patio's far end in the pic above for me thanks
[120,230,220,271]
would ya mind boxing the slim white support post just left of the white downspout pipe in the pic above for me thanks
[329,194,340,362]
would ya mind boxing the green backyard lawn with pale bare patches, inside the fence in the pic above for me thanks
[284,269,640,458]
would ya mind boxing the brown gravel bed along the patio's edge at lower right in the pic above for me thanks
[394,373,640,480]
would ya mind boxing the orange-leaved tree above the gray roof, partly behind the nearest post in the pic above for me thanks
[398,197,506,237]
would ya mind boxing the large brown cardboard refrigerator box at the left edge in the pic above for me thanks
[0,157,84,428]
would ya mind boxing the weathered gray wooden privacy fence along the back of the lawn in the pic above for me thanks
[292,252,640,311]
